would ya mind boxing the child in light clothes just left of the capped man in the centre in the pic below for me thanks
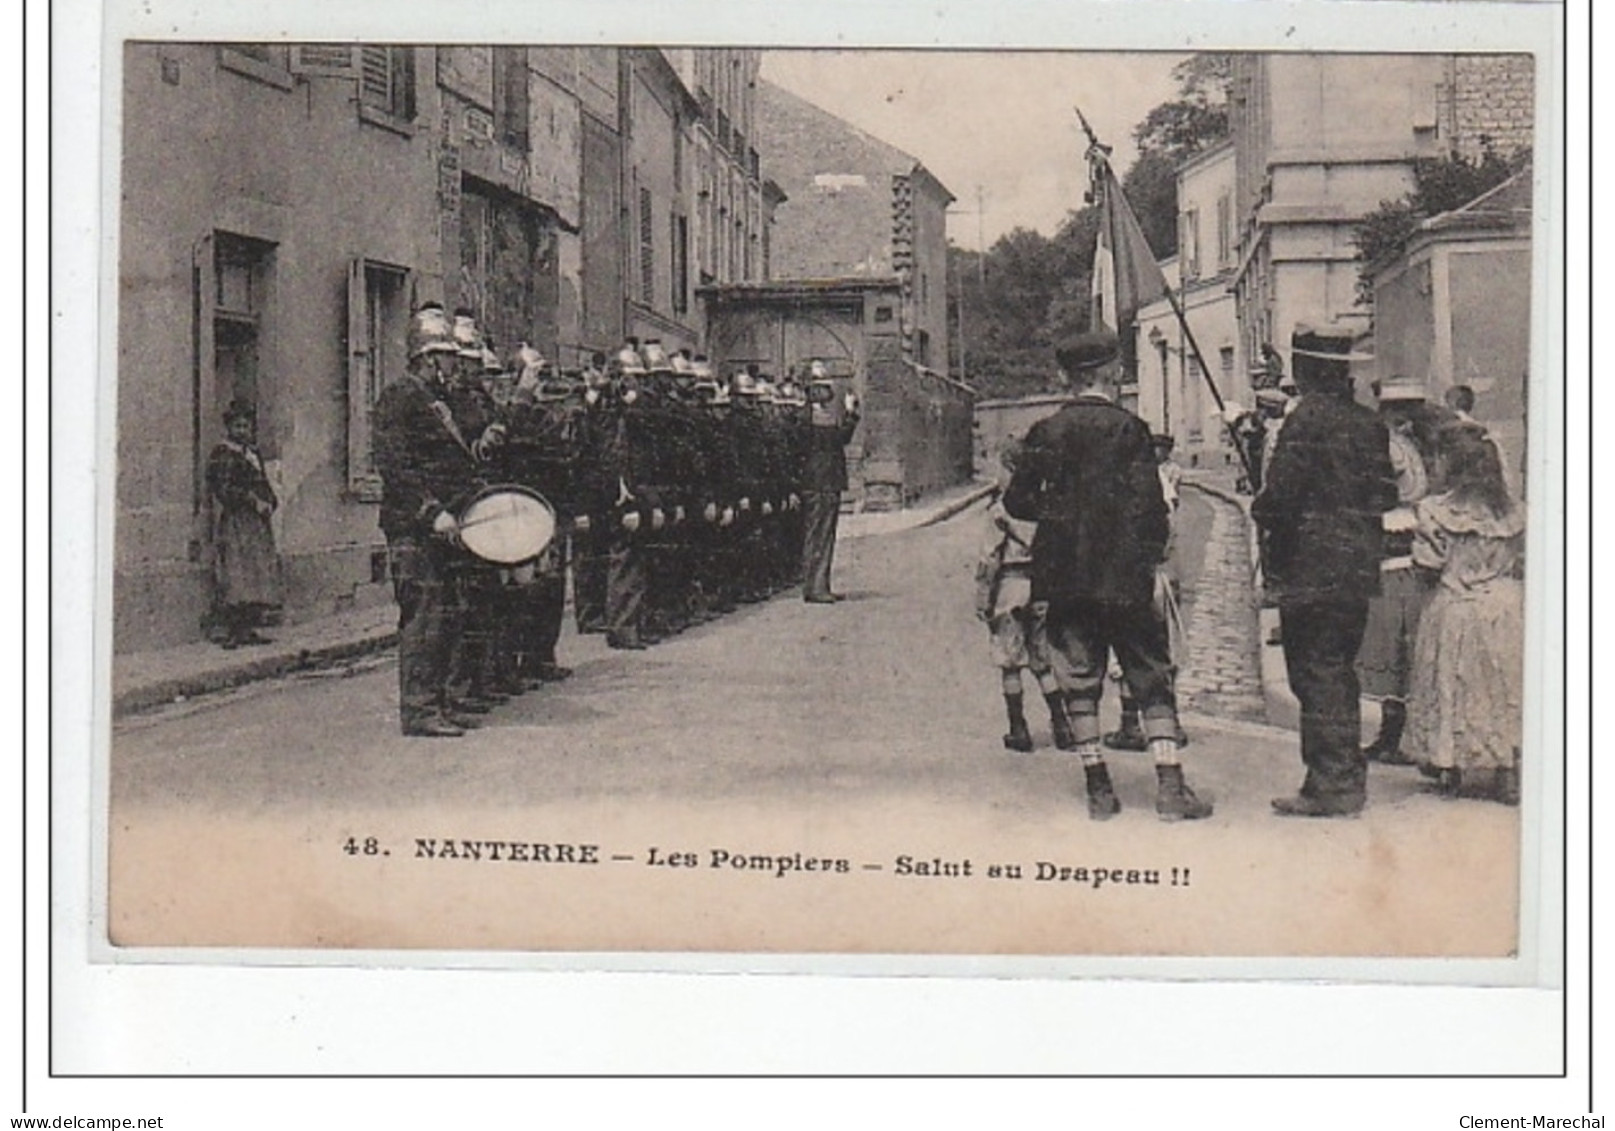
[975,441,1076,753]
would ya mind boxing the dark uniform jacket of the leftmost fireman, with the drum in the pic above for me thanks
[375,375,481,538]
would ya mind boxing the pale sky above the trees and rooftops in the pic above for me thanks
[762,50,1185,249]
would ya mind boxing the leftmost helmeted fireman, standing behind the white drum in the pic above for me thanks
[375,302,481,738]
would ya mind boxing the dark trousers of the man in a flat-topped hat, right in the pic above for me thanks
[1279,598,1368,805]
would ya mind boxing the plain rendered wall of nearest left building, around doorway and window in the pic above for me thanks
[115,44,443,651]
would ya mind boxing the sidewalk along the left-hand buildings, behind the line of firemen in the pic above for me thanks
[111,483,992,719]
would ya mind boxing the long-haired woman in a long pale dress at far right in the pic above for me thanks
[1408,425,1525,805]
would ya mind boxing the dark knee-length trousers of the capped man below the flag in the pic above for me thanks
[1045,598,1177,742]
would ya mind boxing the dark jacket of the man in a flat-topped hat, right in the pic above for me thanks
[1250,393,1397,603]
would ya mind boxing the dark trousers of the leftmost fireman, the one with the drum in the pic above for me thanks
[388,536,462,730]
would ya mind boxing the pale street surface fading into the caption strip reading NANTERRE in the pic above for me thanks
[110,507,1518,955]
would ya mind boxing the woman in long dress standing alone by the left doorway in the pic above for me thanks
[207,401,281,648]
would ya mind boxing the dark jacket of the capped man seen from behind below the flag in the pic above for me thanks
[1005,396,1168,604]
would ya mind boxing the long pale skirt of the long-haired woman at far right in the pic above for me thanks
[1402,578,1525,771]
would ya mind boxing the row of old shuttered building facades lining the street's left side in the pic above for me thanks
[113,42,780,651]
